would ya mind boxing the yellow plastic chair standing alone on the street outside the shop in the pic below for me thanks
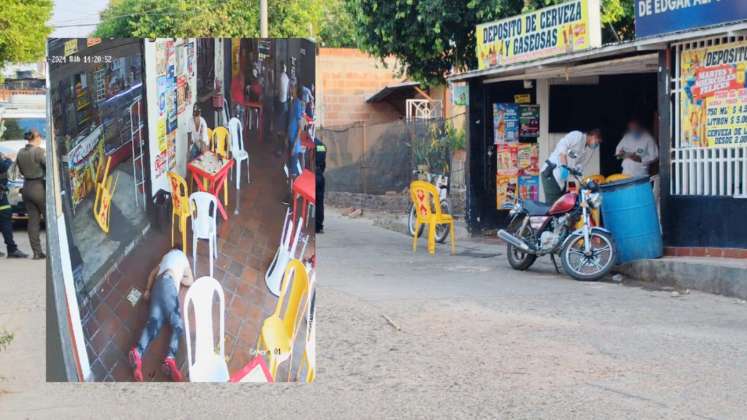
[410,181,456,255]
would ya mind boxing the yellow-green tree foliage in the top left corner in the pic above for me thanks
[0,0,52,67]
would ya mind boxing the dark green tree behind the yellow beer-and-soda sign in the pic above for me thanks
[347,0,634,84]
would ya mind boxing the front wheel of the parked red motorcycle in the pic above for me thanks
[560,231,617,281]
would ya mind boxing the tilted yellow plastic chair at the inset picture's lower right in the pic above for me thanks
[258,259,309,381]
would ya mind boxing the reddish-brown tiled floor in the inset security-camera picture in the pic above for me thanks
[81,130,314,381]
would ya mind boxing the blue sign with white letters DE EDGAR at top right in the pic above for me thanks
[635,0,747,38]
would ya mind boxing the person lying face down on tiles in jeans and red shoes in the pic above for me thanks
[129,249,194,382]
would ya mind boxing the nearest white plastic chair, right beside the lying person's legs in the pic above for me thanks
[184,276,229,382]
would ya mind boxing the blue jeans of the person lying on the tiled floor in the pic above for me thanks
[137,271,184,357]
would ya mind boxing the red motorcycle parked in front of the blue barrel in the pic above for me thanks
[498,167,617,281]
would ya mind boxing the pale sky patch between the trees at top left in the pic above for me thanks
[50,0,109,38]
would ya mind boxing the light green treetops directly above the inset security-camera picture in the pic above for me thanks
[95,0,358,43]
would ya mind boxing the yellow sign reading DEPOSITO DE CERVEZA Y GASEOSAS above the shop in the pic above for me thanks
[476,0,602,69]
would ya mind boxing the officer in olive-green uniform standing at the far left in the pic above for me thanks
[16,129,47,260]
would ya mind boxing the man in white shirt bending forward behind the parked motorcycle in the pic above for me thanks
[541,128,602,205]
